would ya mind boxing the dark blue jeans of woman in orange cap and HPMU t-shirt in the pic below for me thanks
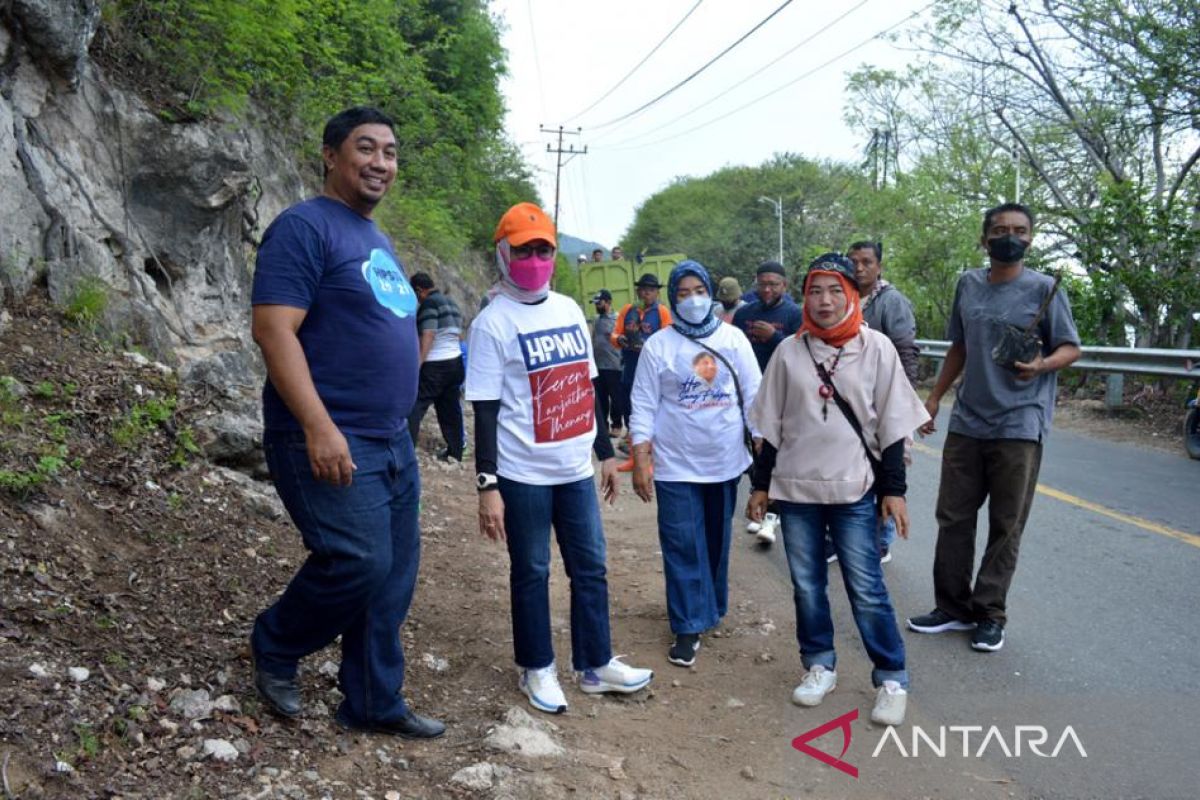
[500,476,612,672]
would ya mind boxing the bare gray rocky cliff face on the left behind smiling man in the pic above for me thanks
[0,0,444,463]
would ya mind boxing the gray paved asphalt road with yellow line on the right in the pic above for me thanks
[734,422,1200,799]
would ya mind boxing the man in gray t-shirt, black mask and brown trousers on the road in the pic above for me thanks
[908,203,1080,652]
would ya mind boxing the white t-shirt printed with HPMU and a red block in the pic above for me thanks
[464,291,598,486]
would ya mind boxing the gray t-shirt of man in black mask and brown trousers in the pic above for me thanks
[946,267,1079,441]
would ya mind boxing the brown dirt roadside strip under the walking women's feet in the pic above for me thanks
[348,455,1032,799]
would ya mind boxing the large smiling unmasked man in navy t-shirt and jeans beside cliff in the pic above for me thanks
[251,107,445,739]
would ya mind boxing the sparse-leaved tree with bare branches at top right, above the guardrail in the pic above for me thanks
[844,0,1200,347]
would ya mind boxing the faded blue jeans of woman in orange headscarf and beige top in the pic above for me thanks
[779,492,908,688]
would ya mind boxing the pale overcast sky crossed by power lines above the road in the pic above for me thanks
[491,0,928,247]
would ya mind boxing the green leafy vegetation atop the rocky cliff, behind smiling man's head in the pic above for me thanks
[94,0,535,257]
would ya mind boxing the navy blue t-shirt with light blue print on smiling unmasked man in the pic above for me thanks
[251,197,418,437]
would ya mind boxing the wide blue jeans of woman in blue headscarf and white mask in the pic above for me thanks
[654,479,739,636]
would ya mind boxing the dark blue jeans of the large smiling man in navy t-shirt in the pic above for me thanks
[251,428,421,724]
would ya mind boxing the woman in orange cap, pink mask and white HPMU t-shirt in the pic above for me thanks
[467,203,654,714]
